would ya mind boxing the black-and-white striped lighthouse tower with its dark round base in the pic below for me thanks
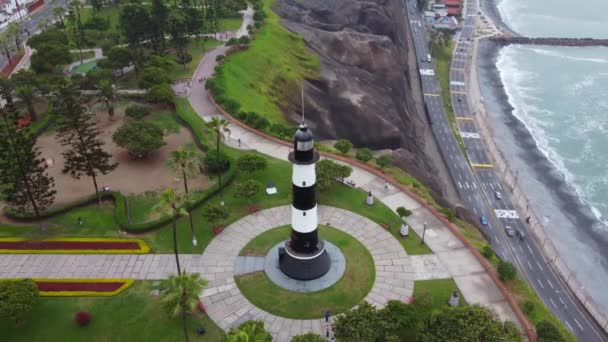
[279,123,331,280]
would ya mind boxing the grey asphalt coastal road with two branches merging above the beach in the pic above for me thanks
[404,0,607,341]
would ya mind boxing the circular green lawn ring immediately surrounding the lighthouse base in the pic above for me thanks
[235,225,375,319]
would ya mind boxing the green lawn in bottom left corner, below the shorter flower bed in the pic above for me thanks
[0,281,225,342]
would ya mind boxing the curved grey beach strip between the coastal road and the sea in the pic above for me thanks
[474,39,608,312]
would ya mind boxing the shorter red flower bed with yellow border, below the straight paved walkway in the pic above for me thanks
[34,279,133,297]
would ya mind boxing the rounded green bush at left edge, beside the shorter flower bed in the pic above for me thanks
[0,279,39,324]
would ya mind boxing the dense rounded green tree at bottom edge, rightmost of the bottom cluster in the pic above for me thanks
[421,305,522,342]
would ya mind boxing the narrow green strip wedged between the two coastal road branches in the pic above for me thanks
[431,40,467,157]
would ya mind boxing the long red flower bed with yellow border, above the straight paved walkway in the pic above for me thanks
[0,238,150,254]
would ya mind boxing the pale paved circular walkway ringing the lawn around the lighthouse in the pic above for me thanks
[202,206,414,341]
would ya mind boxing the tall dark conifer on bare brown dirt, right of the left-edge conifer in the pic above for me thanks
[53,83,118,203]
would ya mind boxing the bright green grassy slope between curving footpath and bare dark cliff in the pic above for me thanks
[216,0,319,123]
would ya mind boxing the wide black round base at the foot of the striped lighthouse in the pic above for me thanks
[279,241,331,280]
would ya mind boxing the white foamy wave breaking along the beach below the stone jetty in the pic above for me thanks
[496,46,608,227]
